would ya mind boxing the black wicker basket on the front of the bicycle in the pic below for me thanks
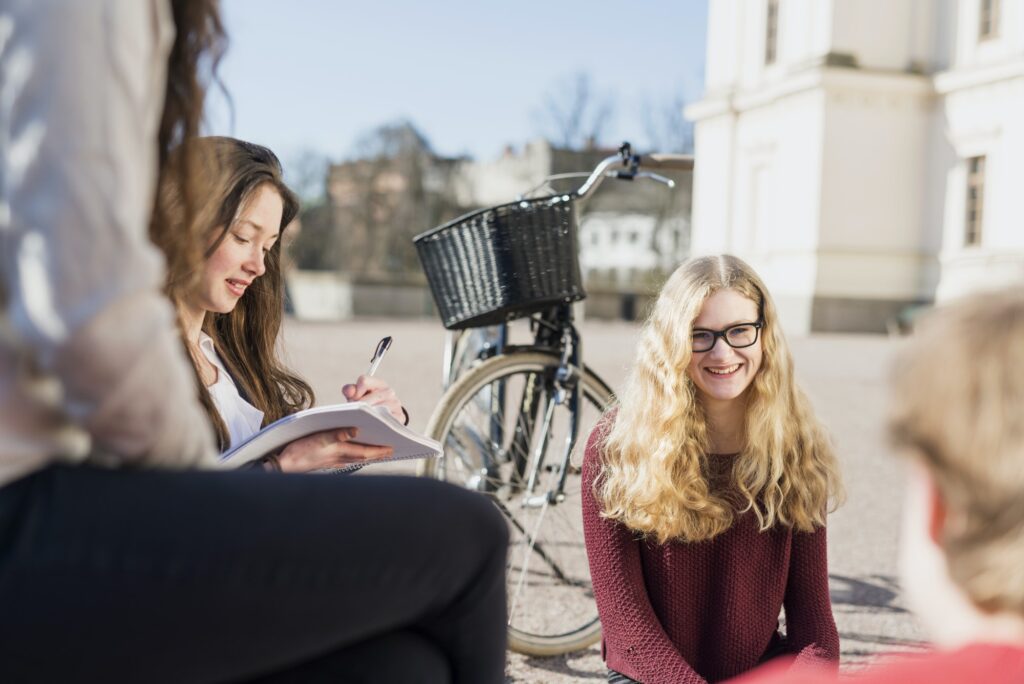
[414,195,587,330]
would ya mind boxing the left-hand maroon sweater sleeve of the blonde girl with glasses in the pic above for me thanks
[582,418,705,684]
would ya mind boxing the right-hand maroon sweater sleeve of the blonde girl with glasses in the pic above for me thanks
[783,526,839,670]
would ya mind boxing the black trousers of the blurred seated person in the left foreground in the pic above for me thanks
[0,466,508,684]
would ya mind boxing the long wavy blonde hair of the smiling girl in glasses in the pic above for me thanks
[595,255,843,544]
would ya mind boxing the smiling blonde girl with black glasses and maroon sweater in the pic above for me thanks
[584,255,841,684]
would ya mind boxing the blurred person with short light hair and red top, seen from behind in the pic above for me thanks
[734,288,1024,684]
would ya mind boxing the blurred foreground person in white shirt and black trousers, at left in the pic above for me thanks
[0,0,507,684]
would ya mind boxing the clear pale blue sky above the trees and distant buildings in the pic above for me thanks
[209,0,707,167]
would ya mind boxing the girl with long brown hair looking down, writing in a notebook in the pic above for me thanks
[153,137,408,472]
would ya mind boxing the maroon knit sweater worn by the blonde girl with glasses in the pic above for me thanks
[583,421,839,684]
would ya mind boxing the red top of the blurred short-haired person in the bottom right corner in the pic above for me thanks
[730,644,1024,684]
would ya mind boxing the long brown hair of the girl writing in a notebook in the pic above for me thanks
[152,137,314,450]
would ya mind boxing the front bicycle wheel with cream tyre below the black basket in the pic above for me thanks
[422,351,611,655]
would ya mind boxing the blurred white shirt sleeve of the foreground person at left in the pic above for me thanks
[0,0,216,483]
